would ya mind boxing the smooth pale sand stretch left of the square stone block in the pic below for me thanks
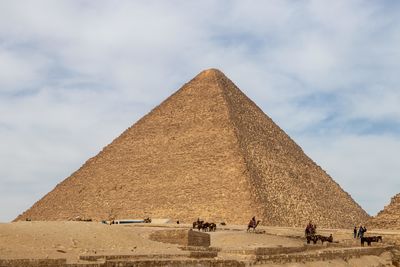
[0,222,186,259]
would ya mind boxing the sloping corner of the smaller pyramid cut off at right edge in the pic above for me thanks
[368,193,400,229]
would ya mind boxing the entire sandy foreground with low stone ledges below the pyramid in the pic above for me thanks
[0,221,400,266]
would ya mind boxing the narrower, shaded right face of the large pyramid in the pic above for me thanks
[212,71,369,227]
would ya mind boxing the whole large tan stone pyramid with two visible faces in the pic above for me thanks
[16,69,369,227]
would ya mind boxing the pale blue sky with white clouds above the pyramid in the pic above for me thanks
[0,0,400,222]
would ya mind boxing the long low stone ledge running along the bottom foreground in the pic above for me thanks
[0,246,400,267]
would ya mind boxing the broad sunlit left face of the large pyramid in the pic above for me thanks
[16,70,255,223]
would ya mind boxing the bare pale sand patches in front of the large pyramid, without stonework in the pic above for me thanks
[0,222,400,267]
